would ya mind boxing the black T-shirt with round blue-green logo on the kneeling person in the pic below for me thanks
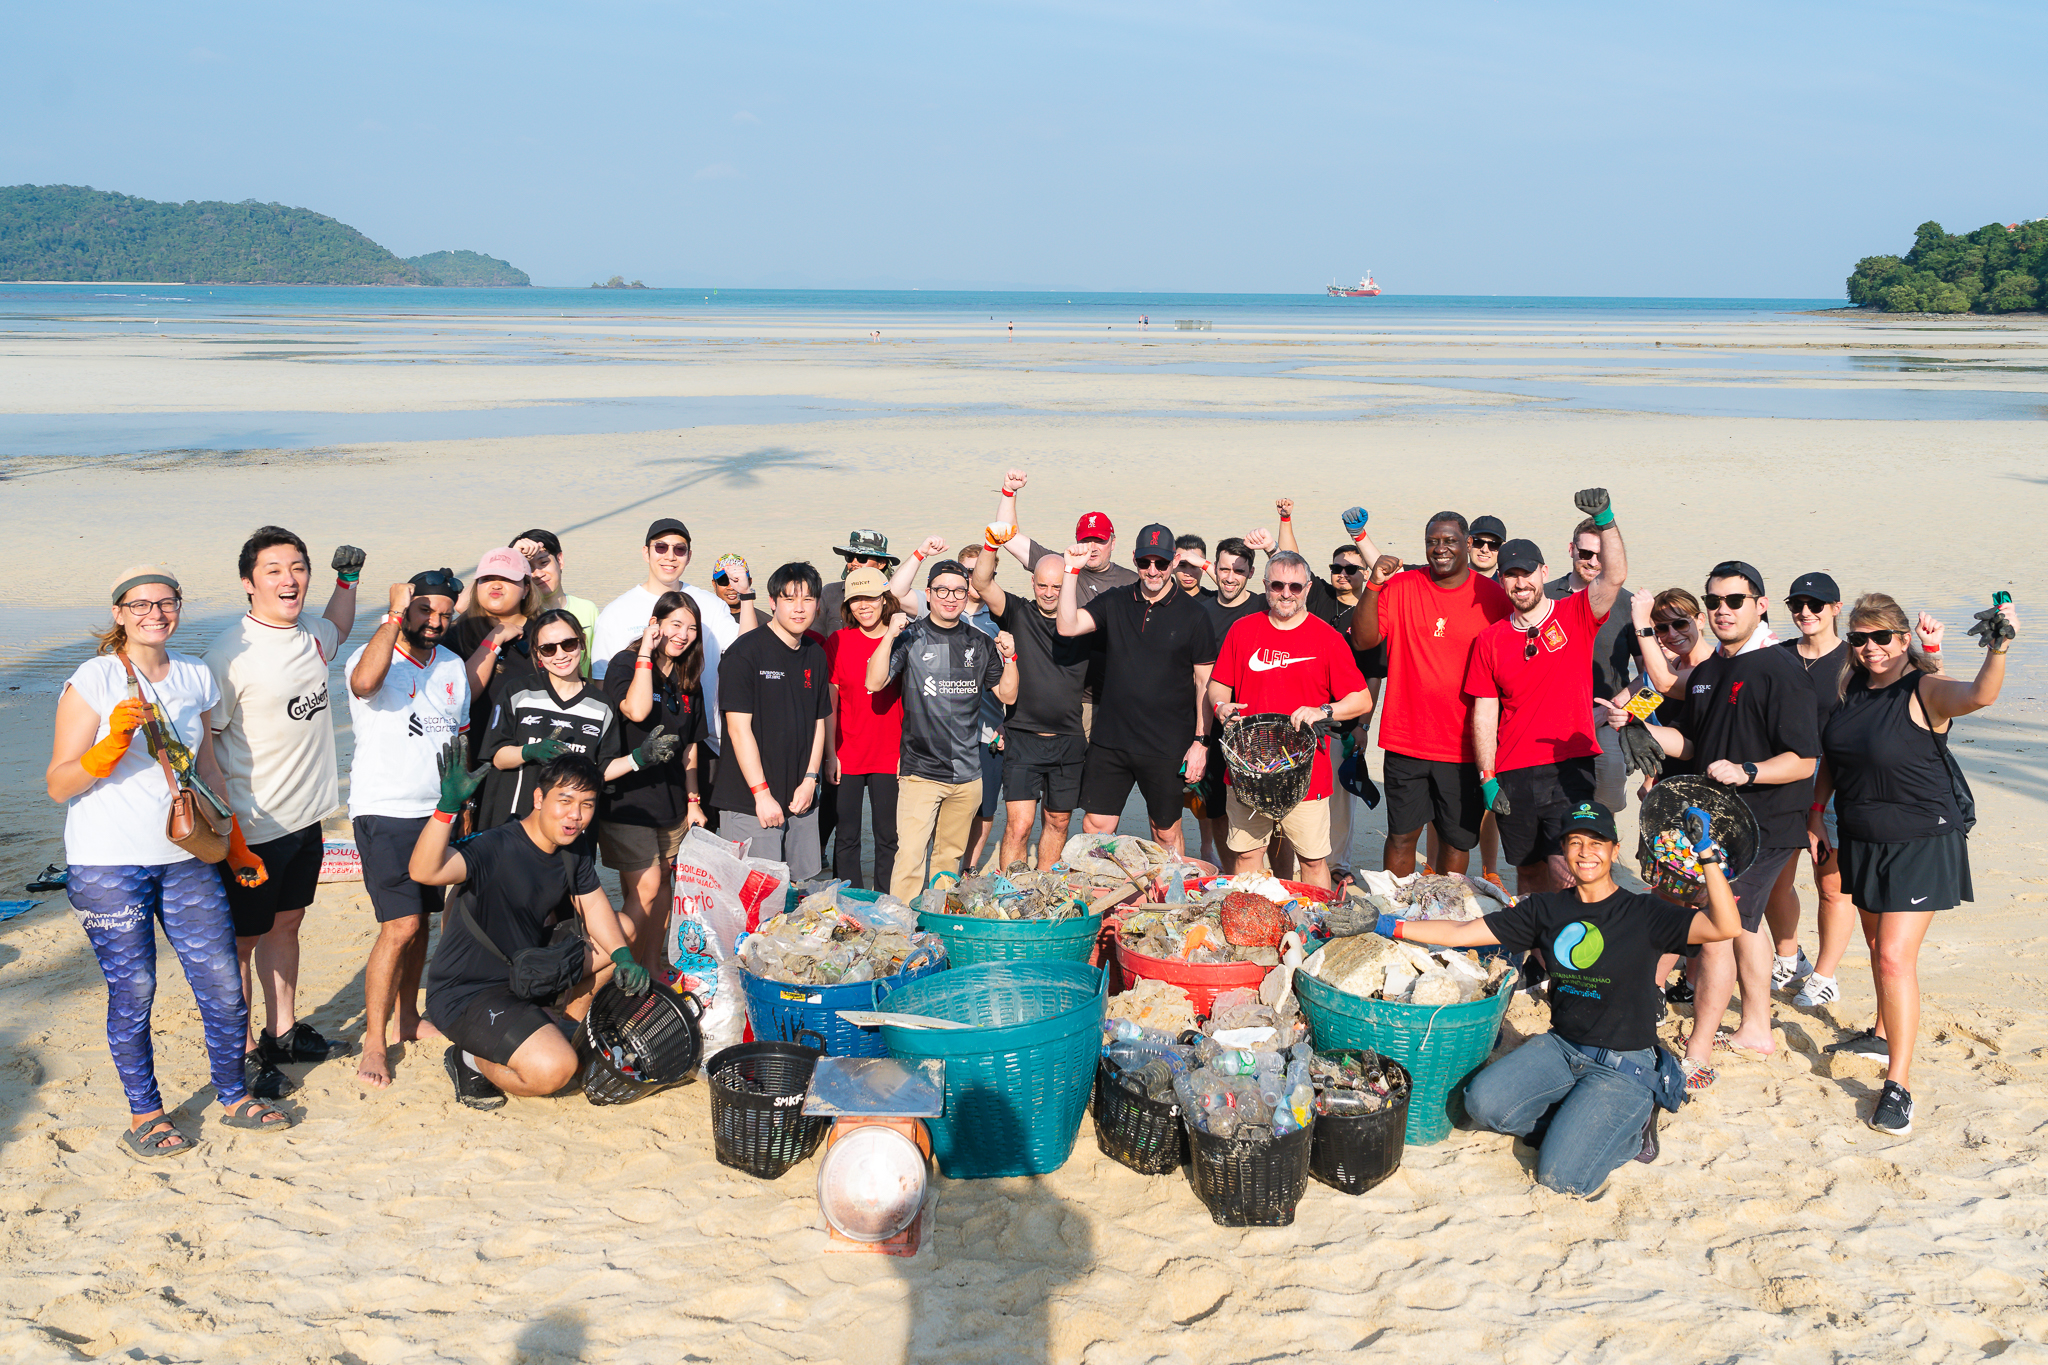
[1487,890,1694,1052]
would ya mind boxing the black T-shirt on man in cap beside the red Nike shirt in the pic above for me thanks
[1087,587,1217,757]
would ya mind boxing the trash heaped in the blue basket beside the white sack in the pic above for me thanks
[739,882,946,986]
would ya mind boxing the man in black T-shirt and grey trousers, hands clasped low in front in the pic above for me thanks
[711,563,831,882]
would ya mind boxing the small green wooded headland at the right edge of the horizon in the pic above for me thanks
[1849,219,2048,313]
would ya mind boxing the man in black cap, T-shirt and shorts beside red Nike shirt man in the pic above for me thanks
[1057,524,1217,851]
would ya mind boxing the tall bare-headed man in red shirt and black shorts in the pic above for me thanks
[1352,512,1515,876]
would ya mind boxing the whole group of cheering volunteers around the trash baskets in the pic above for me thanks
[47,471,2015,1189]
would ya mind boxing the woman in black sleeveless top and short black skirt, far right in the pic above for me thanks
[1808,593,2019,1138]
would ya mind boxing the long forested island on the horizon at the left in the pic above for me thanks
[0,184,532,284]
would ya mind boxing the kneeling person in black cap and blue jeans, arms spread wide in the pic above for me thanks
[1378,802,1739,1195]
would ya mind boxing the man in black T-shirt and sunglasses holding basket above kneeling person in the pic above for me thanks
[1608,559,1821,1089]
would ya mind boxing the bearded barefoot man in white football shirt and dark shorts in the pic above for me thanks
[348,569,469,1091]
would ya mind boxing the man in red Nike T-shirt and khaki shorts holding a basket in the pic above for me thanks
[1208,551,1372,888]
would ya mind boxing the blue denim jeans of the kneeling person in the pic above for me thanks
[1464,1033,1657,1195]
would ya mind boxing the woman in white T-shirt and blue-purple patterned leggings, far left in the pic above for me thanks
[43,565,293,1158]
